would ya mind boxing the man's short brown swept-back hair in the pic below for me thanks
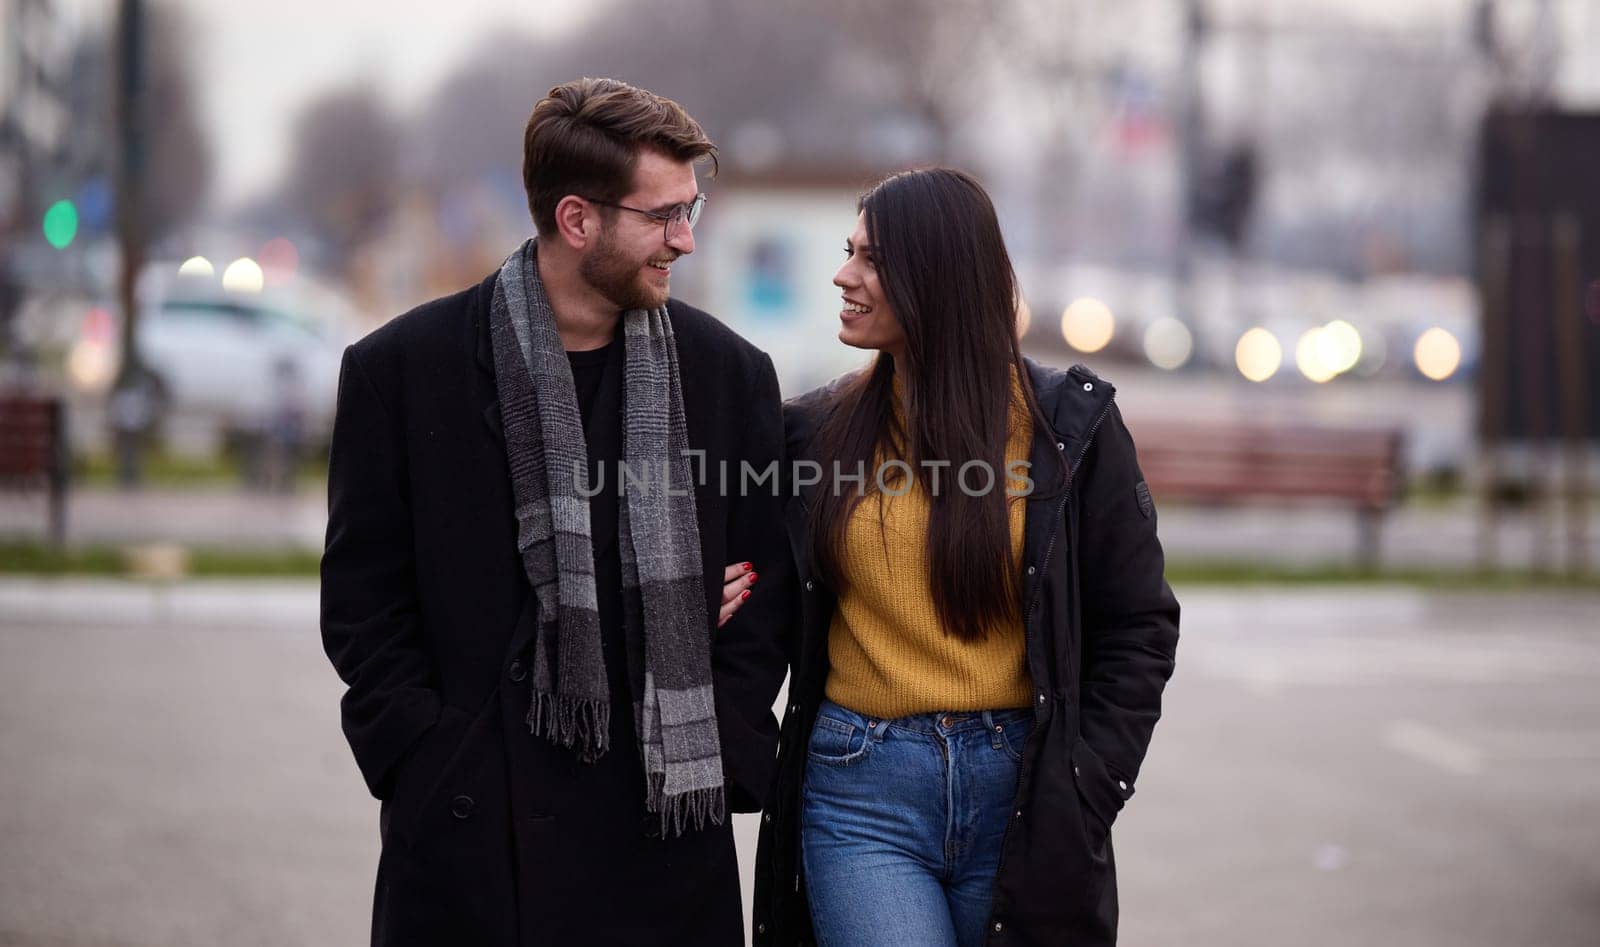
[522,78,717,235]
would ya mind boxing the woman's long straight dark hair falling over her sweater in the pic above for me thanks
[811,168,1046,641]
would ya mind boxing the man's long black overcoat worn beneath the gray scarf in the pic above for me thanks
[322,275,792,945]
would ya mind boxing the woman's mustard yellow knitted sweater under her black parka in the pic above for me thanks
[826,378,1034,718]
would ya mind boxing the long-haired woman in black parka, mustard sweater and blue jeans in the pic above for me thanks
[755,170,1178,945]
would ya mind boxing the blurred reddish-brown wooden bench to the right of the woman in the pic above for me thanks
[1133,422,1405,566]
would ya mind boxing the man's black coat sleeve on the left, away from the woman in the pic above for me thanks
[322,347,440,798]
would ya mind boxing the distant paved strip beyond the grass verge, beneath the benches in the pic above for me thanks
[0,488,1600,569]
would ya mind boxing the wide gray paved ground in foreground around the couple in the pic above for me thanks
[0,579,1600,947]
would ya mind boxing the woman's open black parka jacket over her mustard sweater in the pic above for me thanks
[754,362,1178,947]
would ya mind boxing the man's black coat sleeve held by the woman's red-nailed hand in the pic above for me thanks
[710,355,798,813]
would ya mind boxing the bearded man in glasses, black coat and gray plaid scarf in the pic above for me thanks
[322,80,792,947]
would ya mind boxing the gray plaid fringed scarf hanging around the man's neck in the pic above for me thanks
[490,238,725,837]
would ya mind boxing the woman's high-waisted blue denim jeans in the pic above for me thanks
[800,701,1034,947]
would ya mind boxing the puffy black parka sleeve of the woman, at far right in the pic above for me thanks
[1074,405,1179,806]
